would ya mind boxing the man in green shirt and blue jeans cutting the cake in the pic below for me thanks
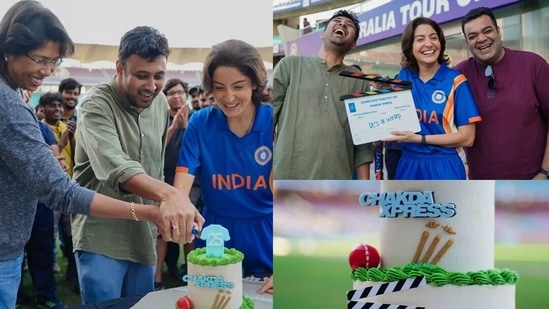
[72,26,204,304]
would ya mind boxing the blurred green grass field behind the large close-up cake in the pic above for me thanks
[274,245,549,309]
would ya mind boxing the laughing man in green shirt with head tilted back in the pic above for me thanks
[273,10,373,179]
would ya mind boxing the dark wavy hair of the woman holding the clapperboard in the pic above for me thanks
[400,17,450,71]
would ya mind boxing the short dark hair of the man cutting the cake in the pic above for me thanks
[118,26,170,63]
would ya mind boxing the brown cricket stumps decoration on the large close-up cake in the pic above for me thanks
[412,221,456,265]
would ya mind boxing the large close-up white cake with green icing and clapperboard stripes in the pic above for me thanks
[347,181,518,309]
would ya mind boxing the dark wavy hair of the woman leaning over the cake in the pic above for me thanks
[202,40,268,105]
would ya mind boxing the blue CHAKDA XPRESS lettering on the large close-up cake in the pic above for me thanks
[358,191,456,218]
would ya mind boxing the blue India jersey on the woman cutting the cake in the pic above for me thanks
[176,104,273,218]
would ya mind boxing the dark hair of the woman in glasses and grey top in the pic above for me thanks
[0,0,74,67]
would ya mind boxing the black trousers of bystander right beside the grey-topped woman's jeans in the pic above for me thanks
[17,203,56,302]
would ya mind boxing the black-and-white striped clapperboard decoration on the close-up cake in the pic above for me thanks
[347,276,427,309]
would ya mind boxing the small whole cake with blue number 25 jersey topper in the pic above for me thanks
[183,224,254,309]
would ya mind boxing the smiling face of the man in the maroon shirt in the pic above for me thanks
[463,15,504,65]
